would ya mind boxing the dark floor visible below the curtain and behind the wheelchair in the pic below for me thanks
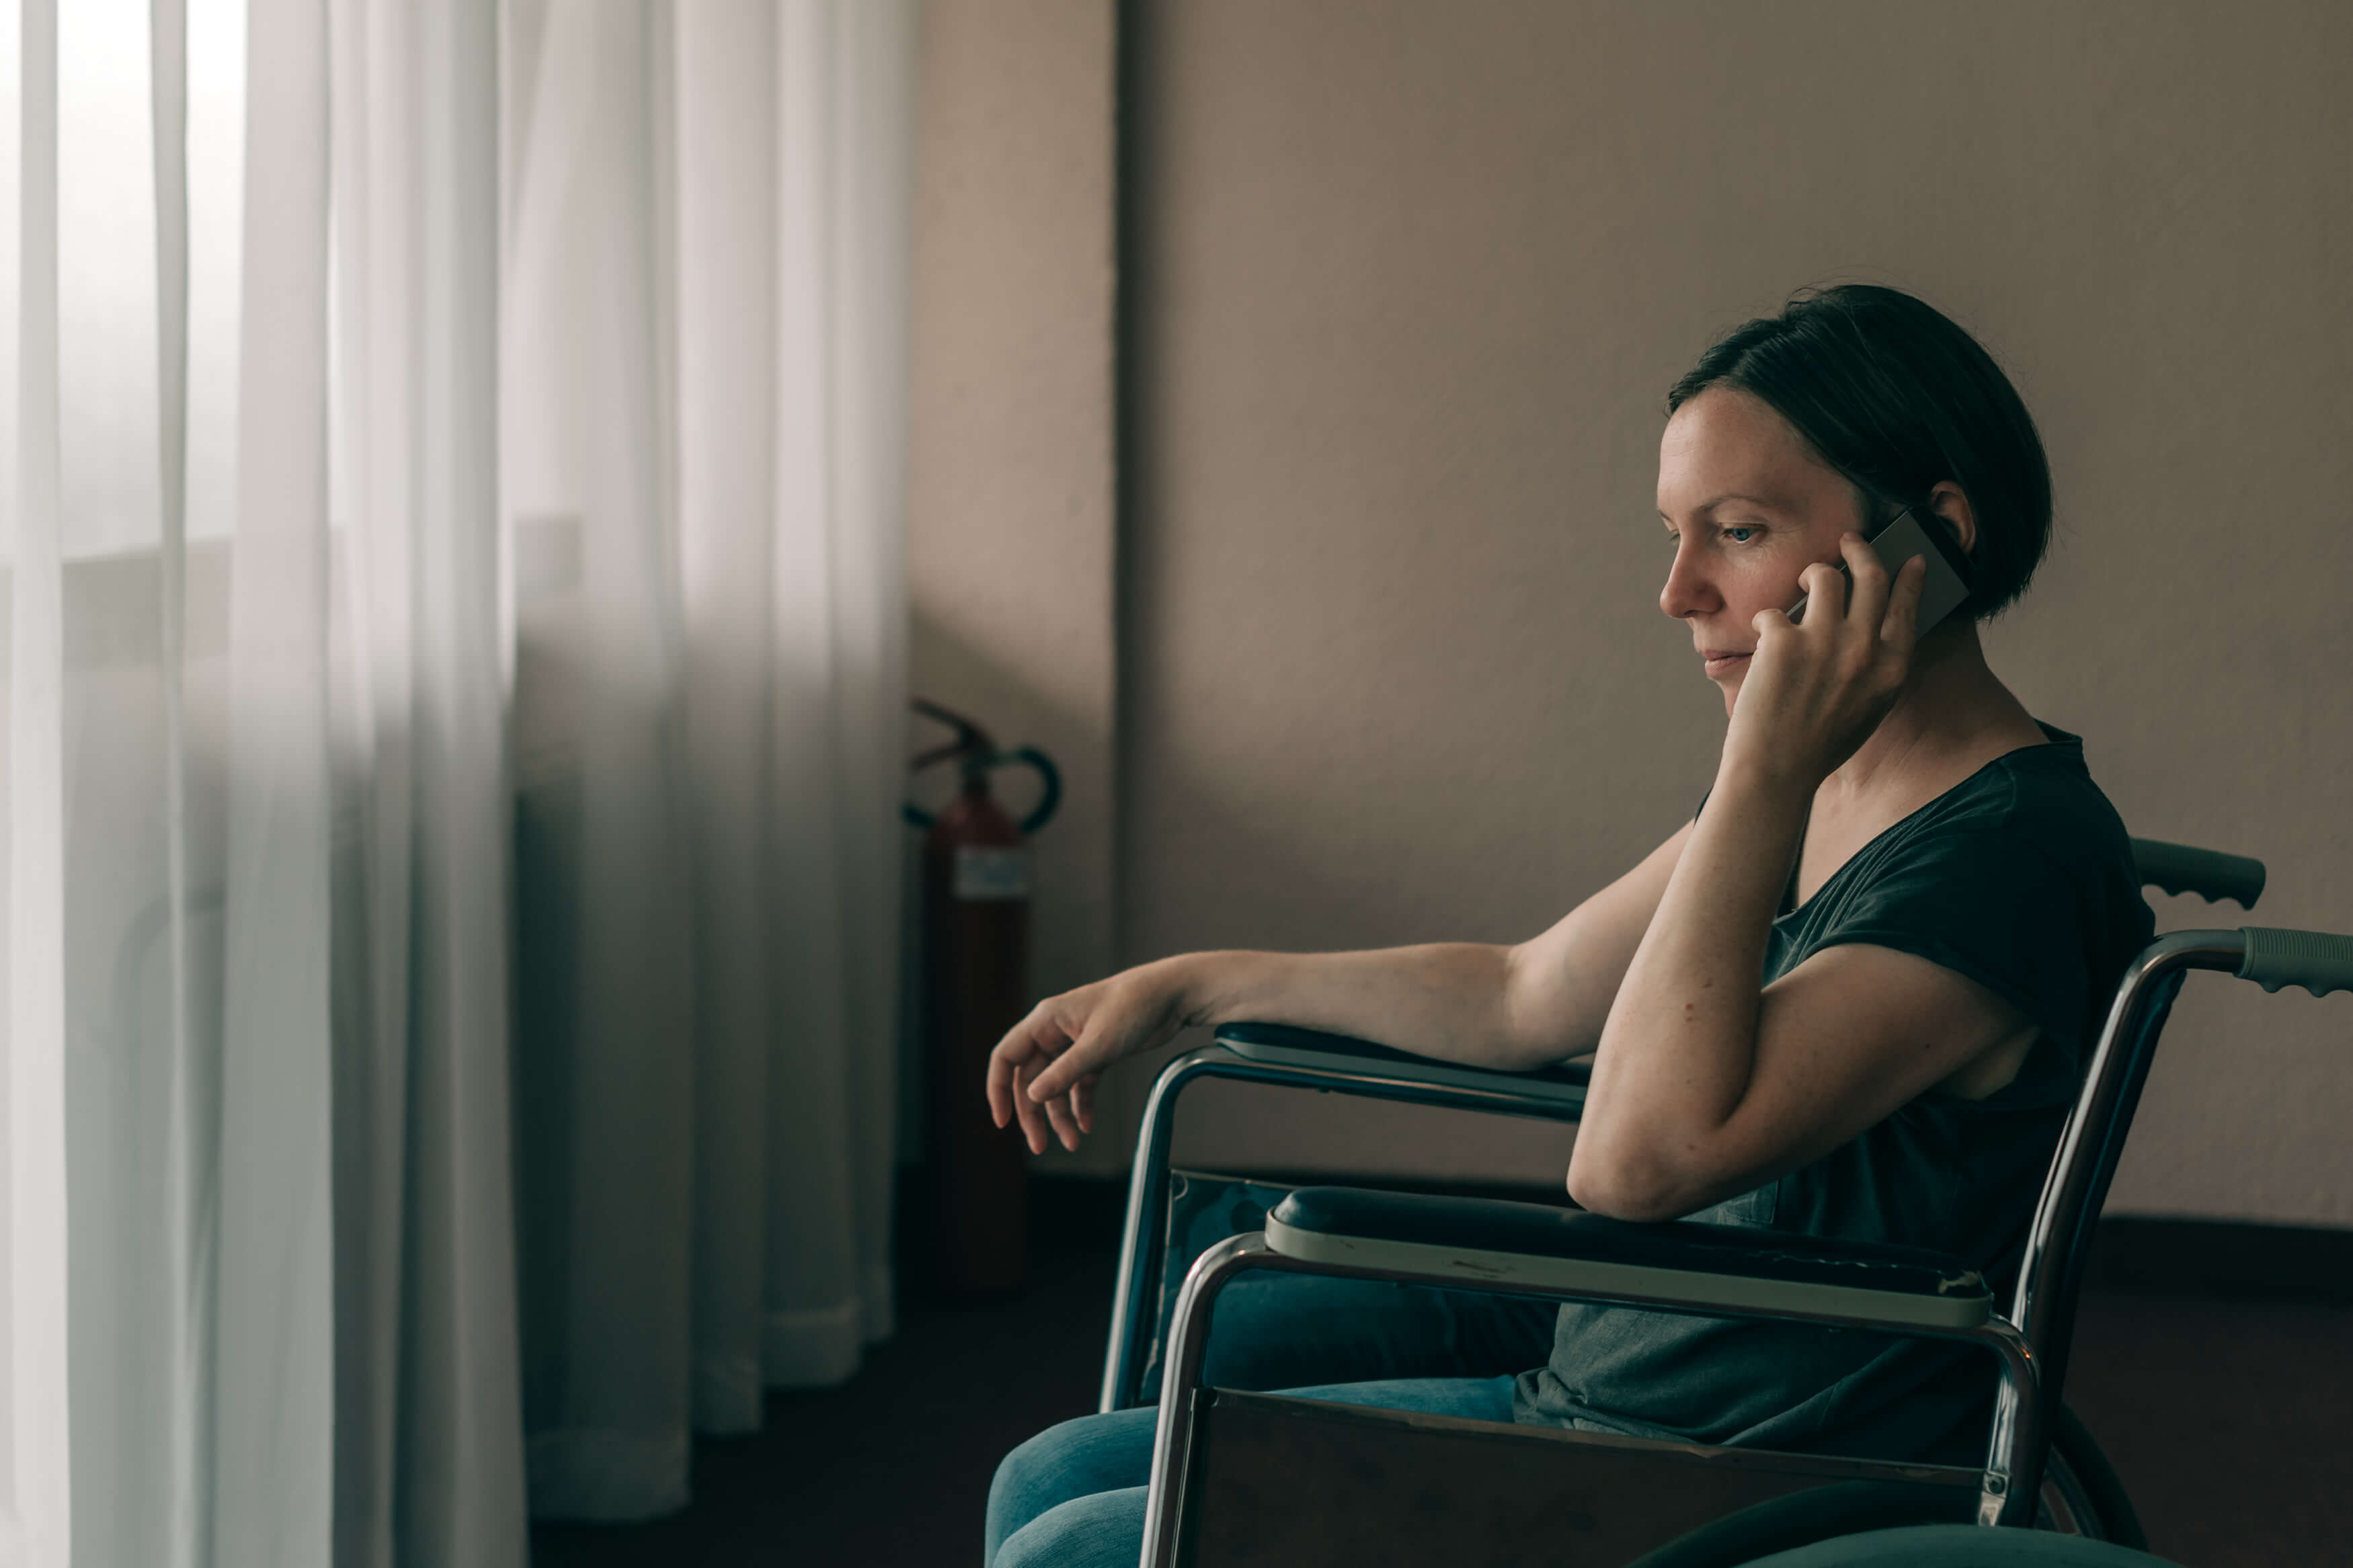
[532,1182,2353,1568]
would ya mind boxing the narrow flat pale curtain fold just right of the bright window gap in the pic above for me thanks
[214,0,334,1568]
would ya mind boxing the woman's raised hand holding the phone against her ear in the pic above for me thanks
[1722,534,1927,790]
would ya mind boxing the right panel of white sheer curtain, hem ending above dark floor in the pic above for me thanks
[506,0,913,1519]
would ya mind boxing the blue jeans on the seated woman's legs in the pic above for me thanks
[984,1274,1558,1568]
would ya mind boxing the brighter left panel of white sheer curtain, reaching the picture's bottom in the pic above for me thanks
[0,0,525,1568]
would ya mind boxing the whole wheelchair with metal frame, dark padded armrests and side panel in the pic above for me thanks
[1101,839,2353,1568]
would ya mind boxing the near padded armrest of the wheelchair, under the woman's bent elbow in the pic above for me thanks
[1266,1187,1993,1328]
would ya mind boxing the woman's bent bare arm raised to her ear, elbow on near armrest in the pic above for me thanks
[1570,534,2028,1220]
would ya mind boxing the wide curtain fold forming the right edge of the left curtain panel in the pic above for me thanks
[329,0,525,1563]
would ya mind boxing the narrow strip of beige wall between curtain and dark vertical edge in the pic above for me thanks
[908,0,1115,1163]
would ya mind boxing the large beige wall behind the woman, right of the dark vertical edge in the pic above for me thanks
[916,0,2353,1223]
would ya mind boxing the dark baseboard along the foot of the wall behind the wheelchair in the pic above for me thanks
[1031,1171,2353,1305]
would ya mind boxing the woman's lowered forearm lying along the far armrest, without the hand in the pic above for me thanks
[1160,943,1560,1069]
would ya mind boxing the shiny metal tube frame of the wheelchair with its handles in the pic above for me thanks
[1101,839,2297,1566]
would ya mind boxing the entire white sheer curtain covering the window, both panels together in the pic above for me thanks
[0,0,911,1568]
